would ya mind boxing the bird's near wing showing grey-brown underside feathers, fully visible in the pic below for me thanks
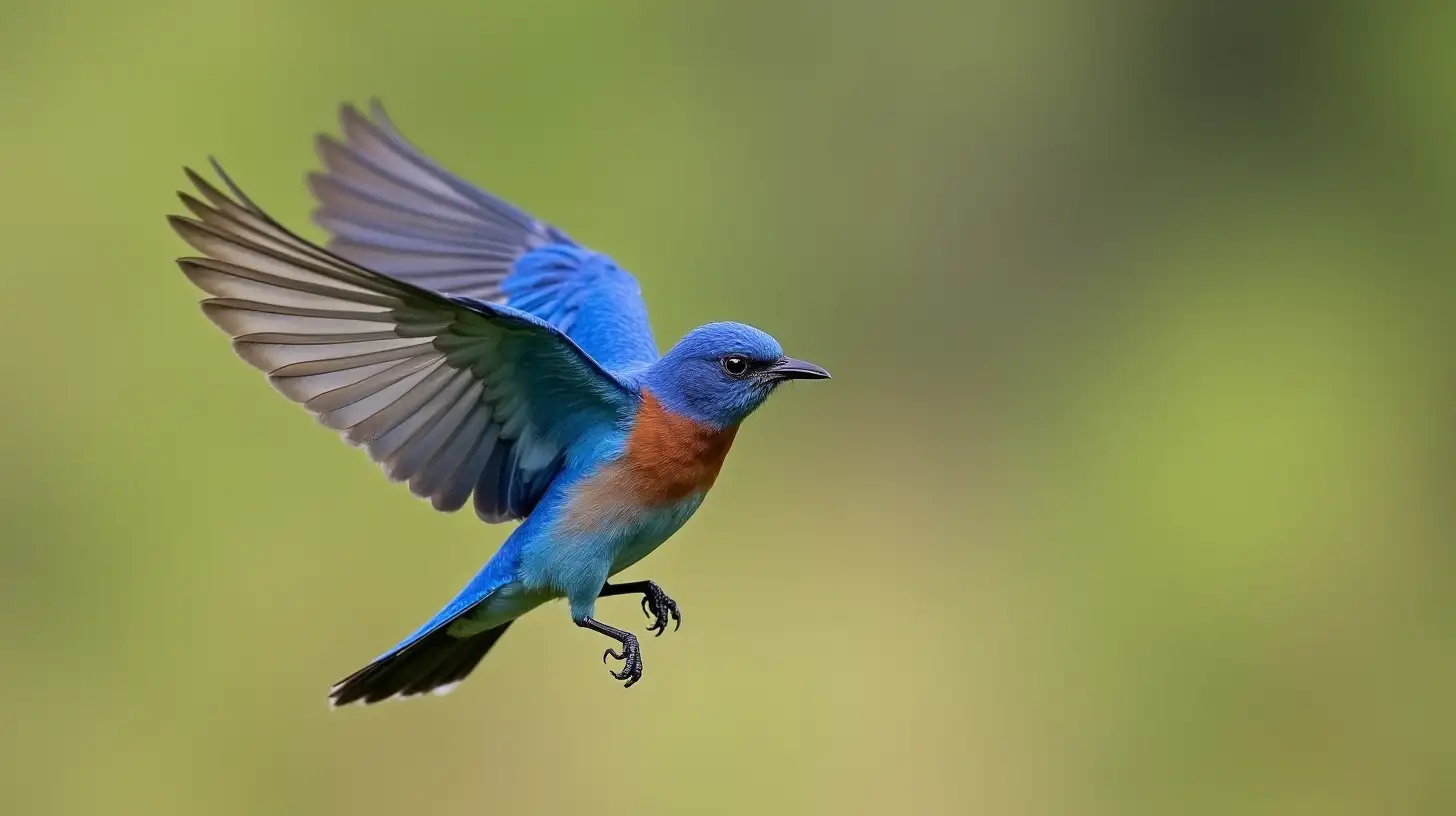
[172,168,633,522]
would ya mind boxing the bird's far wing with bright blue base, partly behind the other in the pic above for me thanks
[309,101,657,369]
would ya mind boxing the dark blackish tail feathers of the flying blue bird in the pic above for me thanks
[329,621,511,708]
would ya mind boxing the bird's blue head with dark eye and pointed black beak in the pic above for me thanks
[645,323,828,428]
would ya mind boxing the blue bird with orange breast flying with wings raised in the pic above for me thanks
[169,99,830,708]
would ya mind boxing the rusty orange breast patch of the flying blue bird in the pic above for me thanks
[566,392,738,529]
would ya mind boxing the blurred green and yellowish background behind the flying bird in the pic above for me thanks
[0,0,1456,816]
